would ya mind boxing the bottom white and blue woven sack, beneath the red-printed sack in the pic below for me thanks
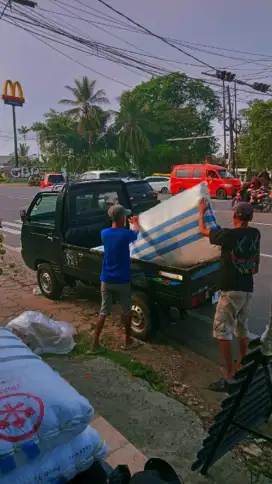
[0,427,107,484]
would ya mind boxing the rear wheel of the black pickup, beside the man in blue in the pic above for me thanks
[131,291,155,341]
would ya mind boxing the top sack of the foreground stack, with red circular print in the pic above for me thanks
[0,328,94,474]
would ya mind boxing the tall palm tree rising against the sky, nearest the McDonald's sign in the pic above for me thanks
[59,76,109,143]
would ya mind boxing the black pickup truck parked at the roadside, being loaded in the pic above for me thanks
[21,180,219,339]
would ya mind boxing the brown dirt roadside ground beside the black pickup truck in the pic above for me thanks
[0,251,222,423]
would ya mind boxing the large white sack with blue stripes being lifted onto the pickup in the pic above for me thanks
[130,182,220,267]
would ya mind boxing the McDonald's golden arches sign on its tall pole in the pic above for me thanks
[2,79,25,168]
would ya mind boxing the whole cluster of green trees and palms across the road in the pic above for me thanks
[28,73,221,174]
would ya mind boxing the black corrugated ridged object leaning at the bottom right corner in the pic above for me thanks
[192,340,272,475]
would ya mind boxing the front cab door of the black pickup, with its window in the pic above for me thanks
[21,193,61,269]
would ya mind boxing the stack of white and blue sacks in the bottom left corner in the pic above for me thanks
[0,328,107,484]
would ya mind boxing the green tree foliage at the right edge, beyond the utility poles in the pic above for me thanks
[238,99,272,171]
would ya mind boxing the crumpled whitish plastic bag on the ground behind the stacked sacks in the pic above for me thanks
[7,311,76,355]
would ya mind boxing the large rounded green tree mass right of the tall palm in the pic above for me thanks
[116,73,220,172]
